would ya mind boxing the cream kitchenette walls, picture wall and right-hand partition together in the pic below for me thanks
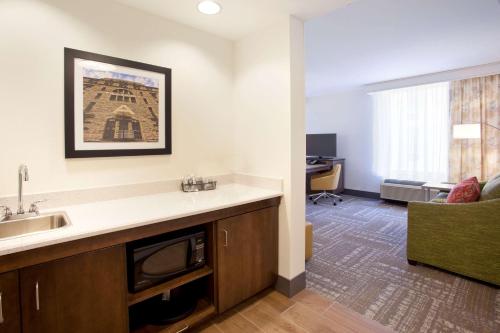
[0,0,305,279]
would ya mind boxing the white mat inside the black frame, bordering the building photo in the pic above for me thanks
[74,58,166,150]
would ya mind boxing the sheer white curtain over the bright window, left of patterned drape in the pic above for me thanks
[372,82,450,182]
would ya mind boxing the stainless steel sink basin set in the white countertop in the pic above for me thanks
[0,212,71,239]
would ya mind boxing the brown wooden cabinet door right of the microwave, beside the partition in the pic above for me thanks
[217,207,278,312]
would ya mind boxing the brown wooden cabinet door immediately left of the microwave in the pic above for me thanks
[20,246,128,333]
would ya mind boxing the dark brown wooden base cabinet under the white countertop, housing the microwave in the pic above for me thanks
[0,197,280,333]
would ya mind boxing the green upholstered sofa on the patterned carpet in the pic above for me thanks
[407,176,500,286]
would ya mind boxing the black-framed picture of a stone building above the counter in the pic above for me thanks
[64,48,172,158]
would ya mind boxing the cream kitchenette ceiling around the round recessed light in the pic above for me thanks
[114,0,352,40]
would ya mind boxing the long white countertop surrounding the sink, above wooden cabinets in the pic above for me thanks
[0,184,282,256]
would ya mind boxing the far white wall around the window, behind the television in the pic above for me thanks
[306,63,500,192]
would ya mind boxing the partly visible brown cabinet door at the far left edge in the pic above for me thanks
[0,271,21,333]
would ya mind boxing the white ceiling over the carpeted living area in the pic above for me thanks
[305,0,500,96]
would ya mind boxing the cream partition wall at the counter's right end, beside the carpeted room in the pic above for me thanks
[234,18,305,279]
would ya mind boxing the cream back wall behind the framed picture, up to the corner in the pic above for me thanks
[0,0,233,196]
